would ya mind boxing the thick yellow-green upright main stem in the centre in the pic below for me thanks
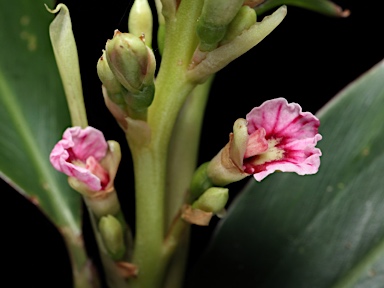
[127,0,203,288]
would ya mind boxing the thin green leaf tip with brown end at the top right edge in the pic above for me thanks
[255,0,350,17]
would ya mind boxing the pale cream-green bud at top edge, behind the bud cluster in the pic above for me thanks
[128,0,153,47]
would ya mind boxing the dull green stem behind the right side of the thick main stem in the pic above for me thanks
[164,77,213,288]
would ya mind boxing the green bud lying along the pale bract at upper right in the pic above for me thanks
[220,6,256,45]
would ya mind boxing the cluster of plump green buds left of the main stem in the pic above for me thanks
[97,30,156,130]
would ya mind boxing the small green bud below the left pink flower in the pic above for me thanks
[99,215,125,260]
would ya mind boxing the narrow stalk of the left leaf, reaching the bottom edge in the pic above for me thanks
[60,229,100,288]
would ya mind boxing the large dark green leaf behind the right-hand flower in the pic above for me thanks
[190,61,384,288]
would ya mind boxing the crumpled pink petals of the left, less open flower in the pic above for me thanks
[49,127,110,191]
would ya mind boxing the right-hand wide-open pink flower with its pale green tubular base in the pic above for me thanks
[207,98,321,186]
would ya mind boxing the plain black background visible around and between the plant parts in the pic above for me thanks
[0,0,384,287]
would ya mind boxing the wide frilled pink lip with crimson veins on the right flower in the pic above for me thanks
[243,98,322,181]
